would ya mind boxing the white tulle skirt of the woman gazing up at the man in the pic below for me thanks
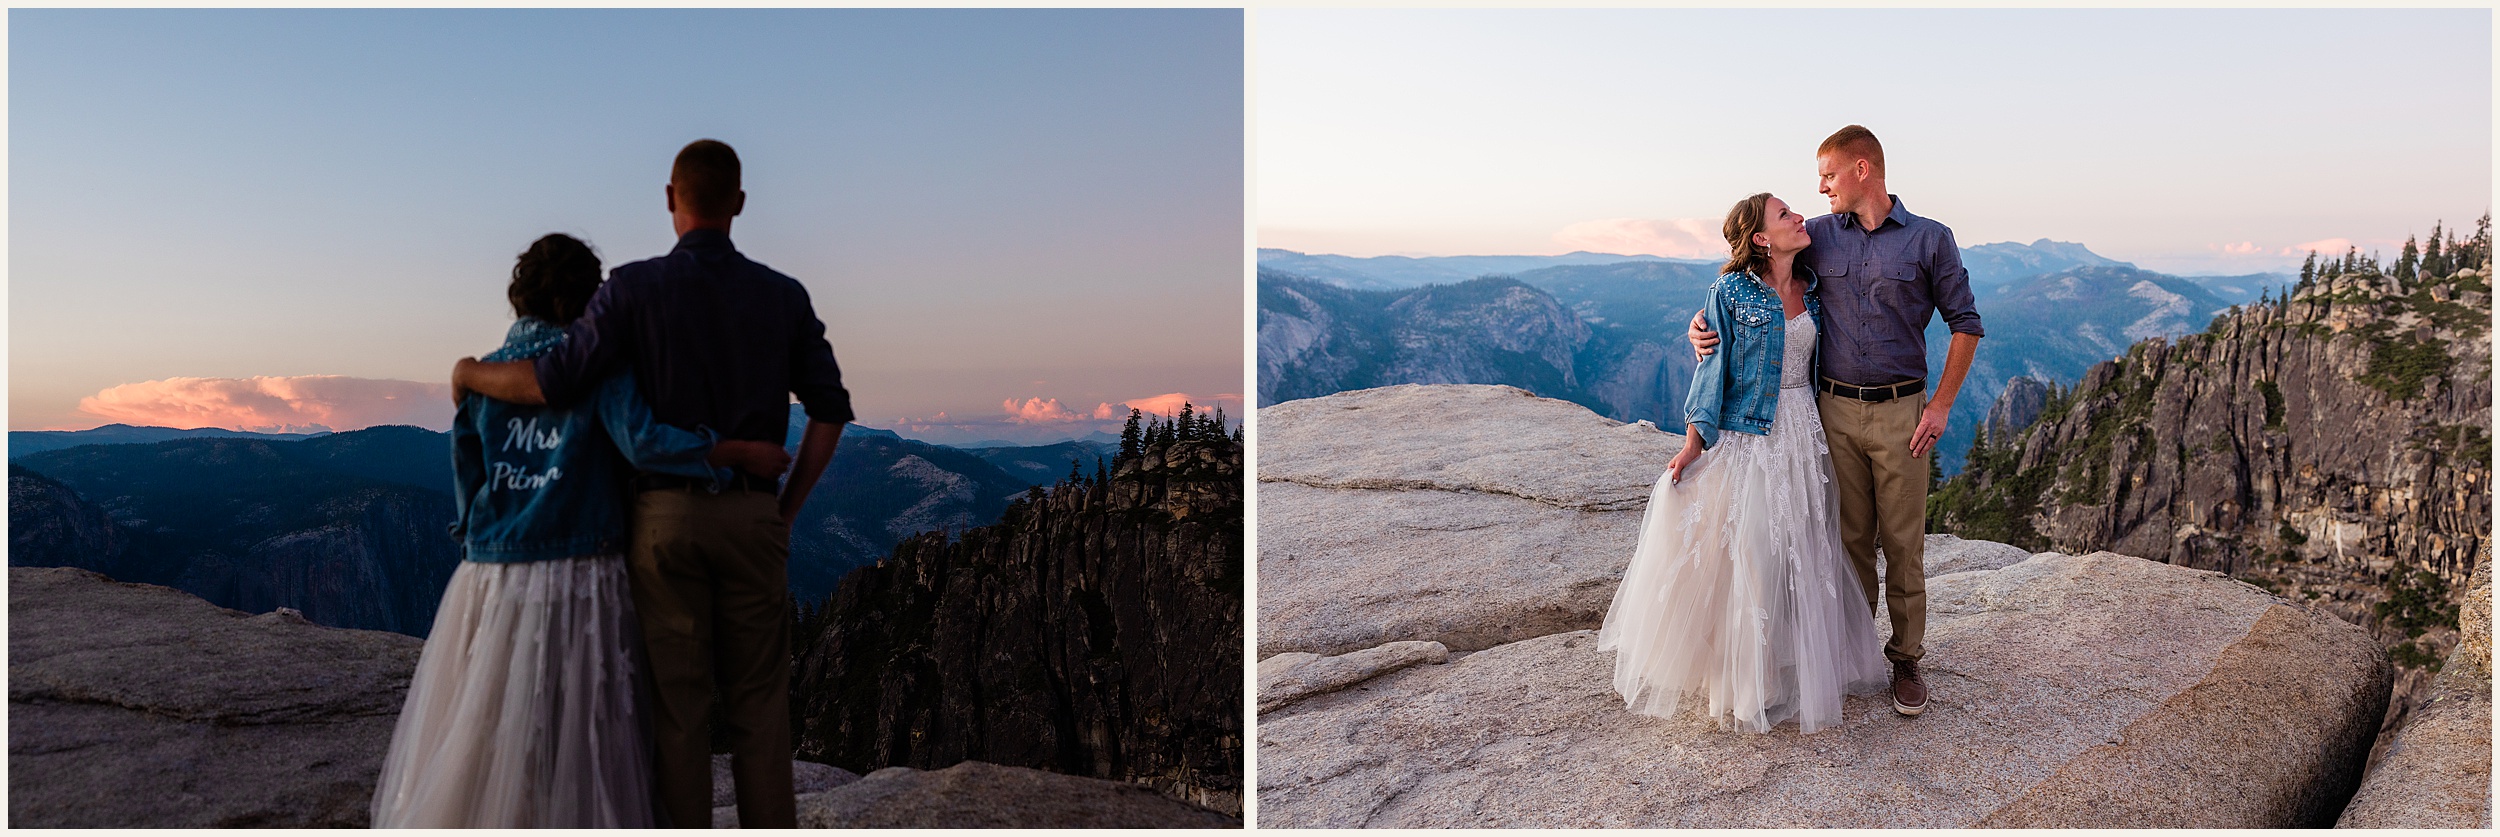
[1598,387,1890,732]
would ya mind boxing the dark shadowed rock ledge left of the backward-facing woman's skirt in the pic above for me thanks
[8,567,423,827]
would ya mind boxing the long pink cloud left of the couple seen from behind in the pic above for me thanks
[78,375,453,432]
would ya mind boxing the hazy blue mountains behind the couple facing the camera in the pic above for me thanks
[1258,240,2293,472]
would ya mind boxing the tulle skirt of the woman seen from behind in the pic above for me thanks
[373,555,653,827]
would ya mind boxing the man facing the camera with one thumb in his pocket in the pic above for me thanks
[1688,125,1983,715]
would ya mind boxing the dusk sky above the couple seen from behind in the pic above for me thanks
[8,10,1245,442]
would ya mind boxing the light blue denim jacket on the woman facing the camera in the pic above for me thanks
[1685,270,1823,450]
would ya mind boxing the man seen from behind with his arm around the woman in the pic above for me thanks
[453,140,853,830]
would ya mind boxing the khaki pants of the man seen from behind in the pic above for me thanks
[628,490,798,830]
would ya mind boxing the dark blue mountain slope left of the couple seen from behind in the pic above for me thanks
[10,444,460,637]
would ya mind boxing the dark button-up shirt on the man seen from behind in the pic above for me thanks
[538,230,853,442]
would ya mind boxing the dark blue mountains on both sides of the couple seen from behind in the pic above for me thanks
[10,409,1110,637]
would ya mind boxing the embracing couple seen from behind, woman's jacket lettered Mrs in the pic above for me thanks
[373,140,853,827]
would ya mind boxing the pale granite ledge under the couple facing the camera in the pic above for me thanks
[1260,387,2390,827]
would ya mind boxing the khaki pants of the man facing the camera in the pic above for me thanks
[1818,390,1935,662]
